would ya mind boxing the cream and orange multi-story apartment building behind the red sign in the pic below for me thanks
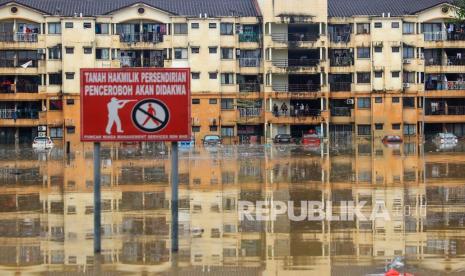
[0,0,465,146]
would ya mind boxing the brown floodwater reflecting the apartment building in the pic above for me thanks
[0,142,465,276]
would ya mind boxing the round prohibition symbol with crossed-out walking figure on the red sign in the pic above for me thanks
[132,99,170,132]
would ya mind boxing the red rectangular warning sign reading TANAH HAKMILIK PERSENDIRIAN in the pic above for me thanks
[81,68,191,142]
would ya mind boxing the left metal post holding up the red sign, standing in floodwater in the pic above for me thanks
[94,142,102,253]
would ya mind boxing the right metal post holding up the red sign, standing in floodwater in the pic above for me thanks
[171,142,179,253]
